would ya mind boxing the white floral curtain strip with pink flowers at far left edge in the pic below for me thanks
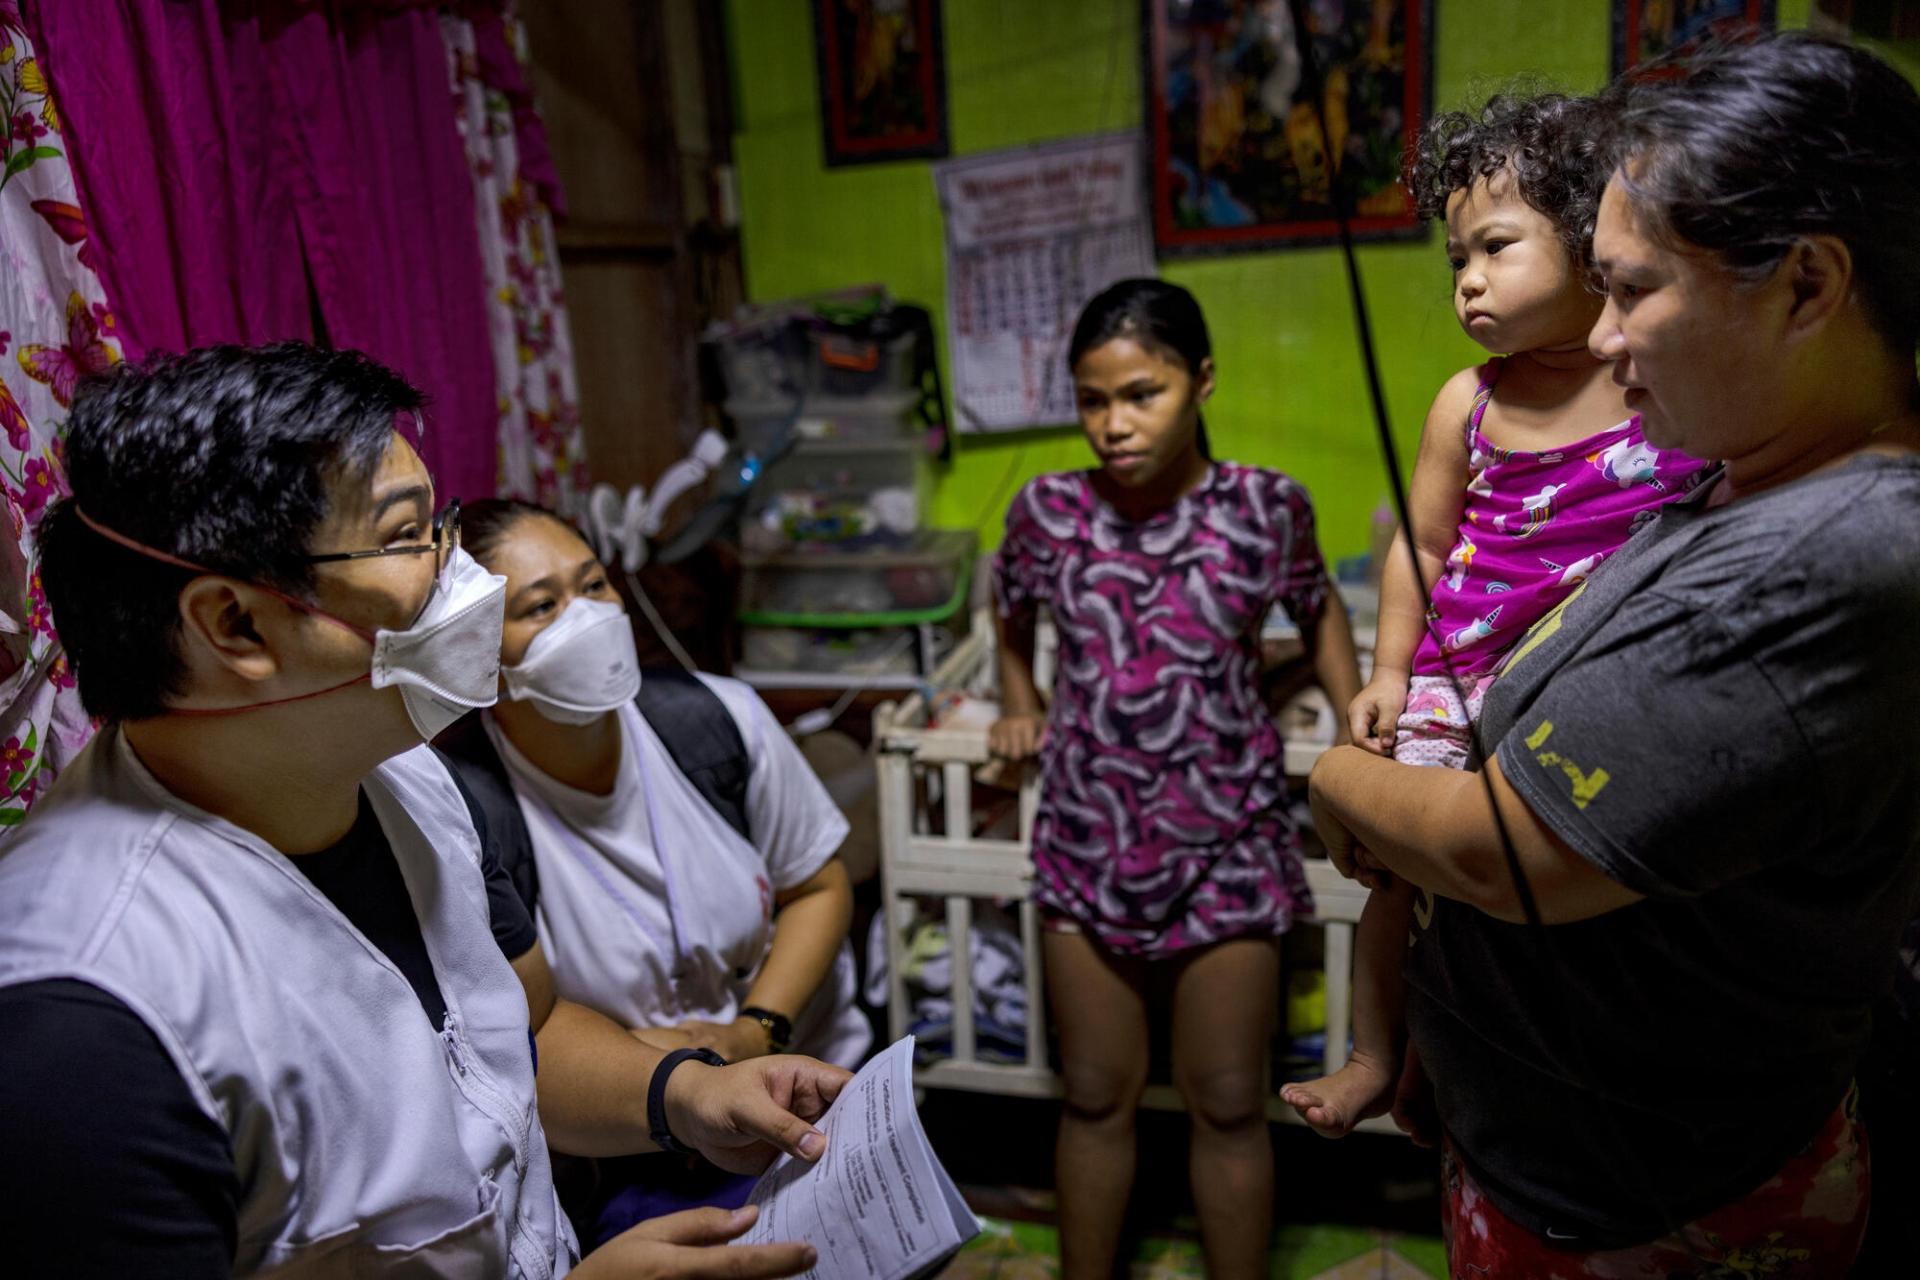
[0,0,121,829]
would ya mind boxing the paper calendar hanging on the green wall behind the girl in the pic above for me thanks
[933,134,1154,432]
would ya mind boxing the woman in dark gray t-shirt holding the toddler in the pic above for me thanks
[1311,35,1920,1276]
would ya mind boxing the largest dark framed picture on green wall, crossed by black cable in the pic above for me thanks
[1144,0,1432,251]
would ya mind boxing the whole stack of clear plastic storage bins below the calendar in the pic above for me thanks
[710,303,977,689]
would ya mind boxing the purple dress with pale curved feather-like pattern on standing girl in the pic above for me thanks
[995,462,1331,958]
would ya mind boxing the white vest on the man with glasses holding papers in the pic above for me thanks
[0,733,576,1280]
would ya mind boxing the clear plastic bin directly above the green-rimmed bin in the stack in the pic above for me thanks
[741,436,931,553]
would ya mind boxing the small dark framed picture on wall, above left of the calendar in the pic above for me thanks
[814,0,947,169]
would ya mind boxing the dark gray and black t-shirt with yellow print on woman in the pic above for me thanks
[1407,457,1920,1247]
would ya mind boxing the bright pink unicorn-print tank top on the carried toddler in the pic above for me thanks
[1413,357,1707,676]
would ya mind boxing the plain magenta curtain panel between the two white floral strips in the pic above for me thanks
[27,0,497,499]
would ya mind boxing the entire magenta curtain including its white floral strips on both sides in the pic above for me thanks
[0,0,588,831]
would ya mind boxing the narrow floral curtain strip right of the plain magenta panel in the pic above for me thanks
[440,0,588,514]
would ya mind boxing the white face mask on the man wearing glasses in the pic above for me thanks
[372,547,507,741]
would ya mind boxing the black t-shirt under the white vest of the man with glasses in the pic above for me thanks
[0,793,538,1278]
